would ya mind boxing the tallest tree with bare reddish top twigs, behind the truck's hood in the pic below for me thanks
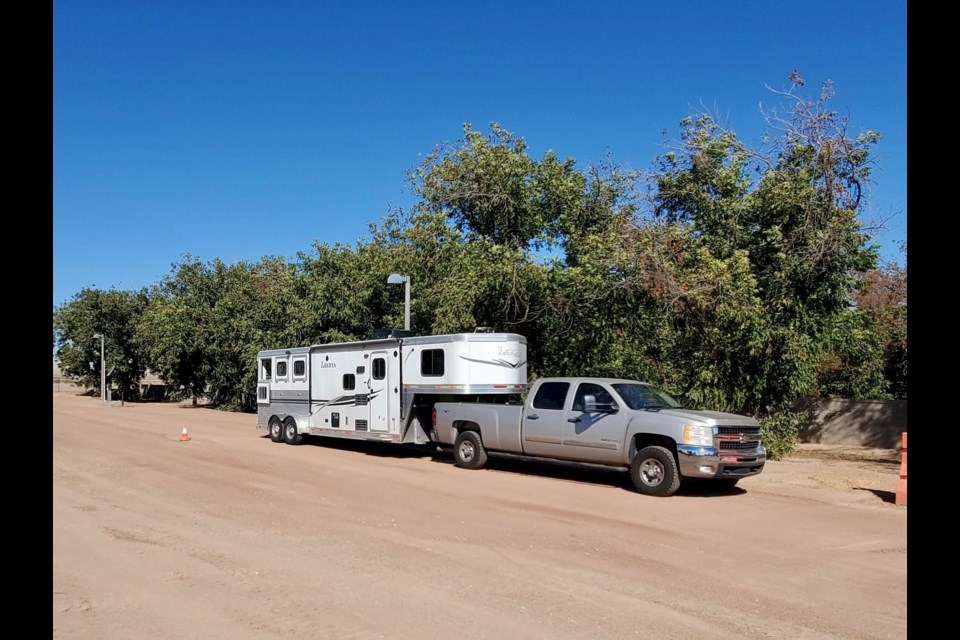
[651,73,879,411]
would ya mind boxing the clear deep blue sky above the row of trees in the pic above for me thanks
[53,0,907,307]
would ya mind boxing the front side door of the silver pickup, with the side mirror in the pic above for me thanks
[563,382,627,462]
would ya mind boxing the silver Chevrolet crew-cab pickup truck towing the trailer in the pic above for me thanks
[433,378,767,496]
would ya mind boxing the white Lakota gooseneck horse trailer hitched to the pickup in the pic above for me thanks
[257,333,527,444]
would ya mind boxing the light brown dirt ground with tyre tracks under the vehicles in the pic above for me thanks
[53,394,907,640]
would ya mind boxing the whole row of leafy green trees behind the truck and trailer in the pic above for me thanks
[54,73,907,456]
